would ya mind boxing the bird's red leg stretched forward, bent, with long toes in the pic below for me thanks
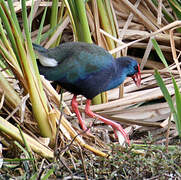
[85,99,130,144]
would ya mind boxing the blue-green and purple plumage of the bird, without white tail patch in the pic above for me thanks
[34,42,138,99]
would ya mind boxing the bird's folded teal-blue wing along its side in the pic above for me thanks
[39,52,114,83]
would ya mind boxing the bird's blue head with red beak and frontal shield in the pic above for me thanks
[118,57,141,87]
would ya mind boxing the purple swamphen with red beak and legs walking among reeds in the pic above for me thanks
[33,42,141,144]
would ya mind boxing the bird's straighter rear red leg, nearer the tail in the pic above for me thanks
[71,95,87,131]
